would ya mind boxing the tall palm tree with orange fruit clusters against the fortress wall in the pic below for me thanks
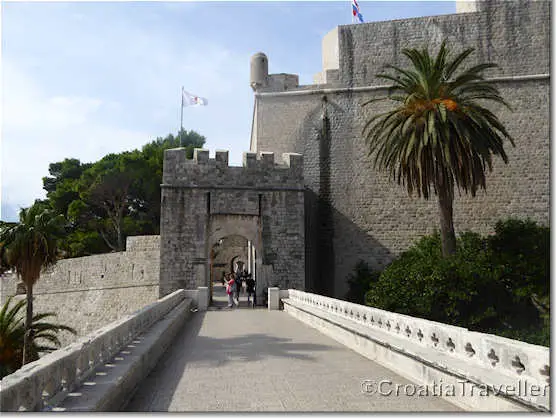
[362,41,514,256]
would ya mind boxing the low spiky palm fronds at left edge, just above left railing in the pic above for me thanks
[0,297,76,378]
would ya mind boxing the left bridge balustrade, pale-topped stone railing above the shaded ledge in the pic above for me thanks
[0,290,186,411]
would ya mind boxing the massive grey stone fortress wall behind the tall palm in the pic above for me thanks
[251,0,550,297]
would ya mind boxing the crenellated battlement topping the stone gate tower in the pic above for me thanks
[163,148,304,187]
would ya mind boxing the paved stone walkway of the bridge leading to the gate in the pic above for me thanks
[126,288,459,412]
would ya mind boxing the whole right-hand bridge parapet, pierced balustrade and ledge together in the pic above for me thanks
[283,290,550,411]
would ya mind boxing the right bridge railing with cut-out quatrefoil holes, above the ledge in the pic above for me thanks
[286,289,550,412]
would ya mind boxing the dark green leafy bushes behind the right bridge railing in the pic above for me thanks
[365,219,550,346]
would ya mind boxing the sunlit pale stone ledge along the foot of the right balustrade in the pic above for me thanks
[283,299,549,412]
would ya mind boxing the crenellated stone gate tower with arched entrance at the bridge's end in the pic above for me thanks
[159,148,305,297]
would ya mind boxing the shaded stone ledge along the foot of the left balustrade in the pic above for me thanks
[48,299,192,412]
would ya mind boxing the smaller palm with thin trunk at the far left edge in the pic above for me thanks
[0,203,64,364]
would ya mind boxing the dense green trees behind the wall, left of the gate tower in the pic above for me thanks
[43,131,205,257]
